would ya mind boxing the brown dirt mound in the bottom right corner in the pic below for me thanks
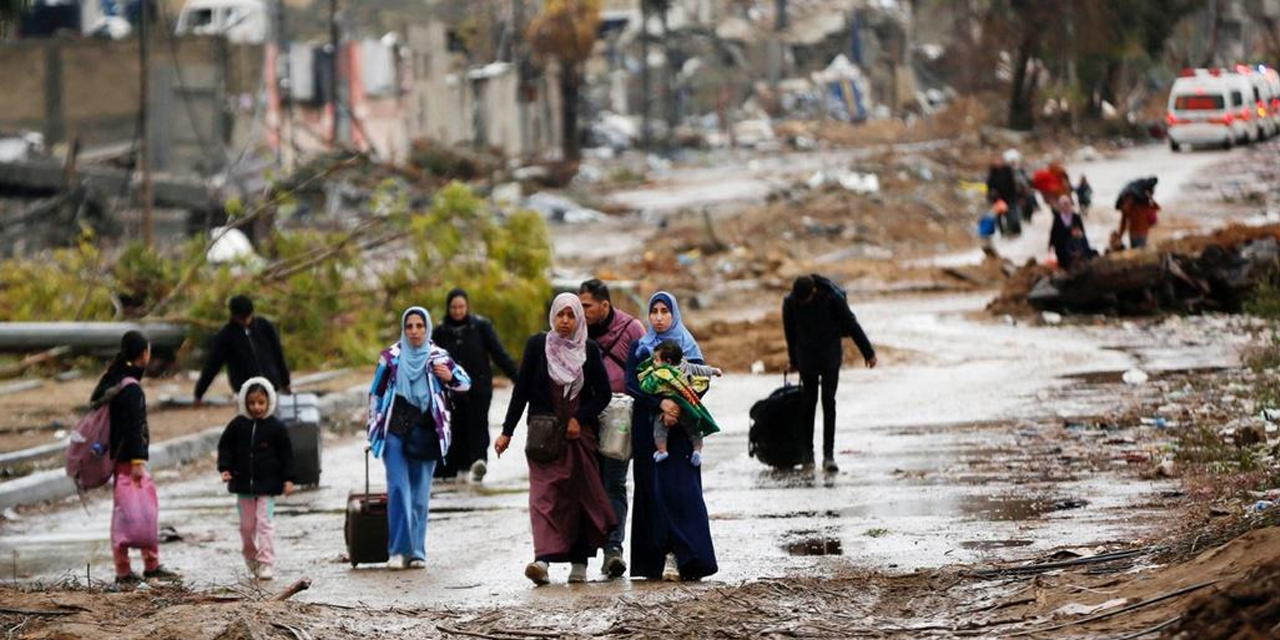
[1164,559,1280,640]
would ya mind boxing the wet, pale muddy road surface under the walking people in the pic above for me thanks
[0,294,1247,608]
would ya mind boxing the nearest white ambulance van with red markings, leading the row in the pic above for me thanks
[1165,69,1251,151]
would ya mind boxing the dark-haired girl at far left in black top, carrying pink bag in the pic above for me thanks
[90,332,178,586]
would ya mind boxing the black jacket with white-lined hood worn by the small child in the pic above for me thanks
[218,378,297,495]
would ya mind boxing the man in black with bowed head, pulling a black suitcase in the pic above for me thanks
[782,274,876,472]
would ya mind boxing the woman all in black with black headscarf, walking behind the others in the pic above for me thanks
[431,289,516,483]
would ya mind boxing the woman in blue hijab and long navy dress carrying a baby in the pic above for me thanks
[627,292,718,581]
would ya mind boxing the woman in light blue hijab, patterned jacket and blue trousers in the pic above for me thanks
[367,307,471,570]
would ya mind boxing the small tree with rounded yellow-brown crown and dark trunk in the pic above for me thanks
[527,0,600,160]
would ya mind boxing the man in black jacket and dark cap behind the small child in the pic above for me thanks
[195,296,289,404]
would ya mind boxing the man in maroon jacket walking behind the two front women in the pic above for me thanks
[577,279,644,577]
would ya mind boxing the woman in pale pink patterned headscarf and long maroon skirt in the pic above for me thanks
[494,293,617,585]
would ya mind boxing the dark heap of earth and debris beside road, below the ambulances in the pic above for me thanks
[988,224,1280,315]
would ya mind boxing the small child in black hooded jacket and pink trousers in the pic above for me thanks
[218,378,294,580]
